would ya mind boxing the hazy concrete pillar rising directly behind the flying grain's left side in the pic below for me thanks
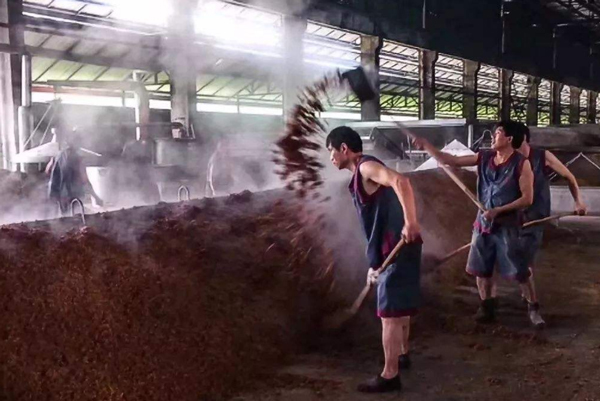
[283,15,307,120]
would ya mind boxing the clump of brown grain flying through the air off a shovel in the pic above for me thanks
[273,75,341,198]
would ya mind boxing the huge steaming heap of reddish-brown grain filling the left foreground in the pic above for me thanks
[0,195,331,401]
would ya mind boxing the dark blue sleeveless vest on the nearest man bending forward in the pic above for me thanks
[348,155,404,268]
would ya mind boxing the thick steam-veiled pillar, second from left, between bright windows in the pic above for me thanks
[168,0,198,136]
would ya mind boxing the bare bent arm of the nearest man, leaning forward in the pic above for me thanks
[360,161,420,242]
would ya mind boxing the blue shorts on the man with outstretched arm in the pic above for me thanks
[467,226,530,283]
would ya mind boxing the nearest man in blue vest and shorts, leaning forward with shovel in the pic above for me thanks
[326,127,422,393]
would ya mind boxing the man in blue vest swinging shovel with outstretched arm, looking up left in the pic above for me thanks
[414,121,533,323]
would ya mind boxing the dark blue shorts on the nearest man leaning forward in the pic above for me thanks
[377,243,423,318]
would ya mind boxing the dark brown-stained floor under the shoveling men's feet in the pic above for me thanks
[235,217,600,401]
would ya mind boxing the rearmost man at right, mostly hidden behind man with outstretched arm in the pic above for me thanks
[519,124,587,328]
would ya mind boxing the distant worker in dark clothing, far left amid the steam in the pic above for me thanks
[46,130,104,215]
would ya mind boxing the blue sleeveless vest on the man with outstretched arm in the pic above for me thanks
[474,151,526,233]
